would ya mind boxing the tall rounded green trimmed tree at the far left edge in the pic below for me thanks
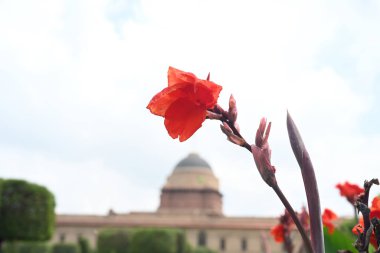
[0,180,55,251]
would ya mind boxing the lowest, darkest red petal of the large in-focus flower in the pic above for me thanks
[165,98,206,142]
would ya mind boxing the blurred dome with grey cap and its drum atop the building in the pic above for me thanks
[158,153,222,215]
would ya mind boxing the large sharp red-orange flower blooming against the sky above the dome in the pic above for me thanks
[147,67,222,142]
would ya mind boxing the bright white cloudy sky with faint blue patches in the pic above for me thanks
[0,0,380,216]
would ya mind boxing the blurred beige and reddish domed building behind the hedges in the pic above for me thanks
[52,153,281,253]
